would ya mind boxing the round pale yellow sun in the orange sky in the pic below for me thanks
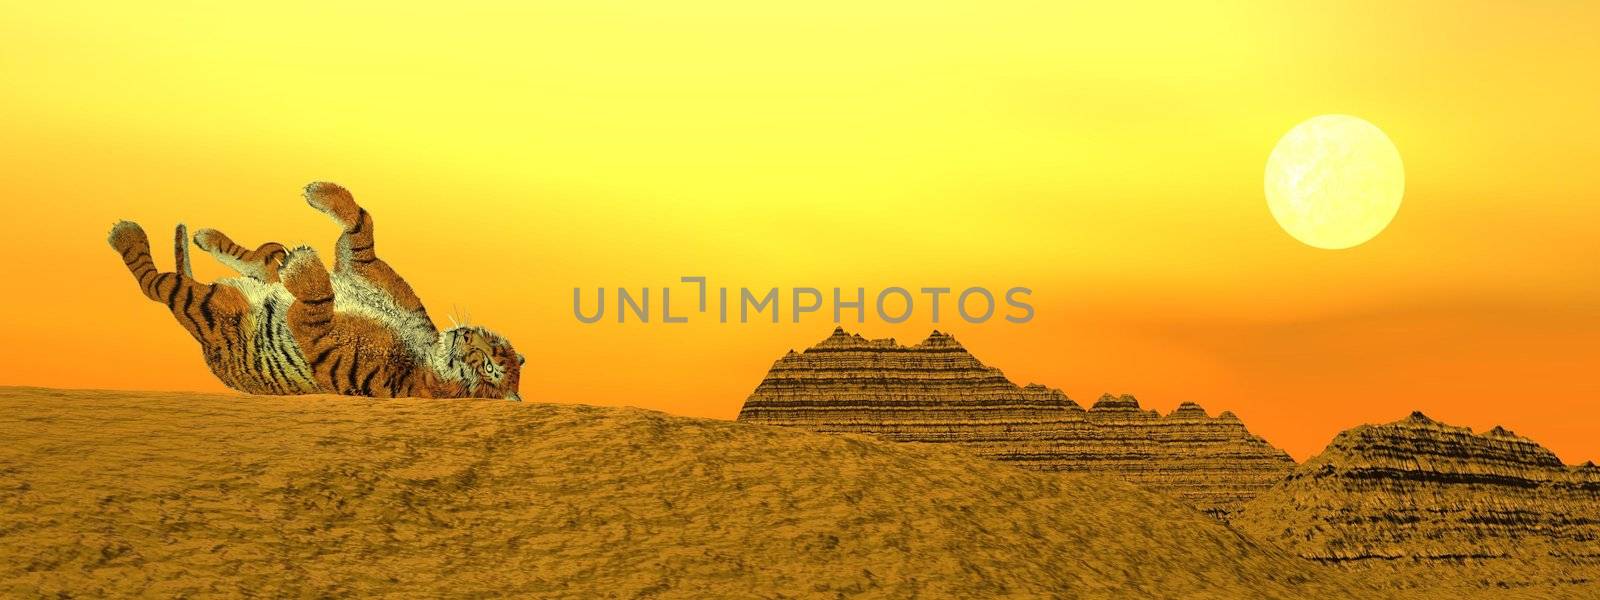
[1266,115,1405,250]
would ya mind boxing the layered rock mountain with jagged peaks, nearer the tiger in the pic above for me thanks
[739,328,1294,518]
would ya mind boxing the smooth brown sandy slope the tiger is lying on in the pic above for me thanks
[0,389,1529,598]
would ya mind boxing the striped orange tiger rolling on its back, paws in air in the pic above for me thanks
[107,182,526,400]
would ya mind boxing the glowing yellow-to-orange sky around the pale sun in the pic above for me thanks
[0,2,1600,462]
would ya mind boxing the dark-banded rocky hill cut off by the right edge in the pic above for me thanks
[1234,413,1600,597]
